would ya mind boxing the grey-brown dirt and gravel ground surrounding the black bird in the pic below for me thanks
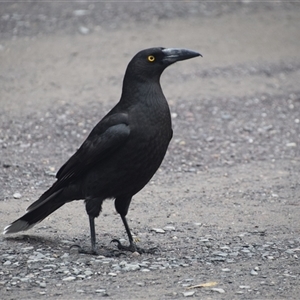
[0,1,300,299]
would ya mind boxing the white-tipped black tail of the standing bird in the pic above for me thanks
[3,190,65,234]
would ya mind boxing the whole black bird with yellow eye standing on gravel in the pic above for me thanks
[4,47,201,253]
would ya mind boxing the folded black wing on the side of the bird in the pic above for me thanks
[56,114,130,181]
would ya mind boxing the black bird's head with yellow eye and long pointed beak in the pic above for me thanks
[126,47,202,81]
